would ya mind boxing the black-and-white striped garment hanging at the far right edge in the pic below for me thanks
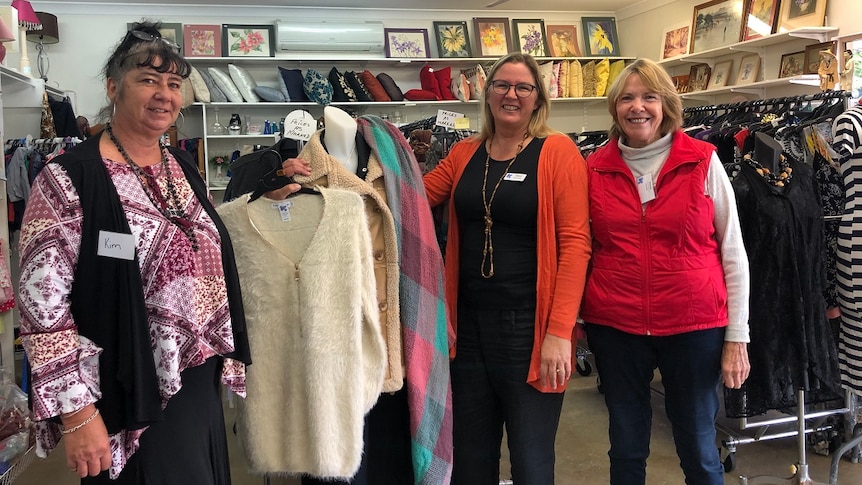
[833,106,862,395]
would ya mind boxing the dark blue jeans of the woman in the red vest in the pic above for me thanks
[586,323,724,485]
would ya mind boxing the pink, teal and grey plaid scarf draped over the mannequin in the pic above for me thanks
[357,115,452,485]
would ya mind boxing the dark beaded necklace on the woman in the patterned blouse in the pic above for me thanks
[105,123,200,252]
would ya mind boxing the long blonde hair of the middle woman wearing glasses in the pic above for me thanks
[477,52,556,141]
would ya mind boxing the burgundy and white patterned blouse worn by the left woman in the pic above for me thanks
[19,155,245,478]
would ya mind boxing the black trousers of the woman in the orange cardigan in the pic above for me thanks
[450,308,563,485]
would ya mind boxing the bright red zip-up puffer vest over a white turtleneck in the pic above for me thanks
[581,131,727,336]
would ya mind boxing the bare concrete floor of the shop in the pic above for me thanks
[10,368,862,485]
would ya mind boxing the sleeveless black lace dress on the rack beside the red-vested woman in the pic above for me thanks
[725,155,841,417]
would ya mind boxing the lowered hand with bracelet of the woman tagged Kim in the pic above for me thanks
[62,404,111,478]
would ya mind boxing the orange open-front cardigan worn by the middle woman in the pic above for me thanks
[424,134,590,392]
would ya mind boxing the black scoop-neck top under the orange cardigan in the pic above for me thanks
[454,138,545,309]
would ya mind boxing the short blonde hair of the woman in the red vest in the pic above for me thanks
[608,59,682,137]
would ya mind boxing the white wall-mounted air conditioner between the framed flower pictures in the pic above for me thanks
[275,20,384,53]
